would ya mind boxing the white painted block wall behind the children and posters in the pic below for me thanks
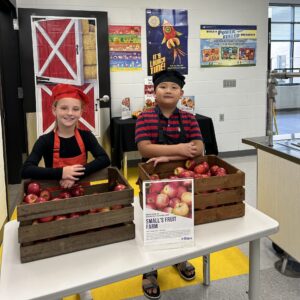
[17,0,269,152]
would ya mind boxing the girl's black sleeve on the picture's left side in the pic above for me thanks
[21,137,62,180]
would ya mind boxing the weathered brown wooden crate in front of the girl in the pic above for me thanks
[17,168,135,263]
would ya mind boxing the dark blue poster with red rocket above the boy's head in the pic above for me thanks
[146,9,188,76]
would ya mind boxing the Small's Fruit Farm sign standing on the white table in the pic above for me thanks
[143,178,194,249]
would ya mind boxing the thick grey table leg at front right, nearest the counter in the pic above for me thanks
[248,239,260,300]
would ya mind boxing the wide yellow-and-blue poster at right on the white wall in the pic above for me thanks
[200,25,256,68]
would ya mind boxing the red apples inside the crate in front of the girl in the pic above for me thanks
[23,182,126,224]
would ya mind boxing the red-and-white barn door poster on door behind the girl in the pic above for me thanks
[31,16,100,136]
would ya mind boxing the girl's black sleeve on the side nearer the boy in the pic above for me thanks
[84,132,110,176]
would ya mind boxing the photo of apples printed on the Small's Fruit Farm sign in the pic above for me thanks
[146,180,193,218]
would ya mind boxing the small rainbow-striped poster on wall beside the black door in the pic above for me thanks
[108,25,142,72]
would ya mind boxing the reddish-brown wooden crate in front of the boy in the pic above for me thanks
[139,155,245,224]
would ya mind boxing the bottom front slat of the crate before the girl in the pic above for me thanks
[20,223,135,263]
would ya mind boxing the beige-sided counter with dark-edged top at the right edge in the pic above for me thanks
[242,134,300,261]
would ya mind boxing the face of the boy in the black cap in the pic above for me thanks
[155,81,183,108]
